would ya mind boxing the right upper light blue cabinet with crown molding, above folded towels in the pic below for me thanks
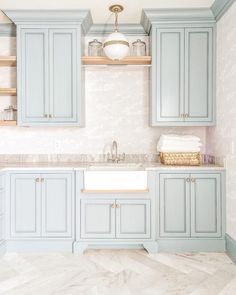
[143,9,215,126]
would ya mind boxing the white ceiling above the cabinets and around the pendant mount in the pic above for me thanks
[0,0,214,23]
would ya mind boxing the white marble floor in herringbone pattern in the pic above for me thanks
[0,250,236,295]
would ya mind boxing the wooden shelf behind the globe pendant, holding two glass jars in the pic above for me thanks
[82,56,152,65]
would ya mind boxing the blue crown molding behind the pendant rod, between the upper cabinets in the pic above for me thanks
[88,24,147,36]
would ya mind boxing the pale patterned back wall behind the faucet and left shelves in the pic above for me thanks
[0,37,206,154]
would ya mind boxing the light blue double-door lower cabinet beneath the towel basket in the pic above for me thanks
[159,173,223,238]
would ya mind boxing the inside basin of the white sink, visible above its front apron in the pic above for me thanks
[88,163,144,171]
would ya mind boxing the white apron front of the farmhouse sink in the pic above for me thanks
[84,171,147,191]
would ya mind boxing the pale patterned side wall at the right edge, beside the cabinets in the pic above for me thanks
[207,2,236,239]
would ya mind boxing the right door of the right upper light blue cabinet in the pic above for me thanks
[185,28,213,122]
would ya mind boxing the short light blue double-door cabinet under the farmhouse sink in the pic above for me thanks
[81,199,151,239]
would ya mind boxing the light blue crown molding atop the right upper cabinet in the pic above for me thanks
[141,8,215,34]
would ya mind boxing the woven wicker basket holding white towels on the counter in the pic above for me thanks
[160,153,200,166]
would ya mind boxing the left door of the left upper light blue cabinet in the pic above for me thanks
[20,29,49,125]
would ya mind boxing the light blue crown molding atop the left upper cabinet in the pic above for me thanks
[3,9,93,33]
